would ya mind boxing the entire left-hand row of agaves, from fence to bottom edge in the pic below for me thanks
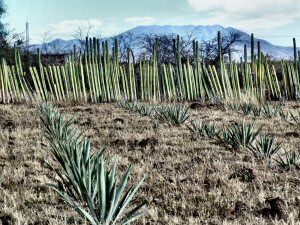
[39,103,146,225]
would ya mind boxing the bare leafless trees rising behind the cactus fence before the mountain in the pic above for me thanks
[71,27,242,64]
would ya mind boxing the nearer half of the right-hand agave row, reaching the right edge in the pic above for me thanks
[187,120,300,170]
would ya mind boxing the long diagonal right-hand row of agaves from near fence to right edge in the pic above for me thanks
[119,101,300,169]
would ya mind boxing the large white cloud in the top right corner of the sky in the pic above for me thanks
[187,0,300,32]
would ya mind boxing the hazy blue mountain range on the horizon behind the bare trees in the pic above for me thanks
[30,25,293,59]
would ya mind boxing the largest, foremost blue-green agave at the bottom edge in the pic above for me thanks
[55,158,146,225]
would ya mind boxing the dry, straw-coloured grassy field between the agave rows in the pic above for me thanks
[0,102,300,224]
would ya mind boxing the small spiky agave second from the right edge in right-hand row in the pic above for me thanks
[249,135,282,159]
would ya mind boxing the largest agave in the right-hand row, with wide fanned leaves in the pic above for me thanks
[216,122,262,150]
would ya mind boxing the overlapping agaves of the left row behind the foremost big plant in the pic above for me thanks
[39,103,105,200]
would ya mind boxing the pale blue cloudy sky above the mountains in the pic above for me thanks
[3,0,300,46]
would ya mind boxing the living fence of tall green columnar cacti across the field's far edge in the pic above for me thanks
[0,32,300,103]
